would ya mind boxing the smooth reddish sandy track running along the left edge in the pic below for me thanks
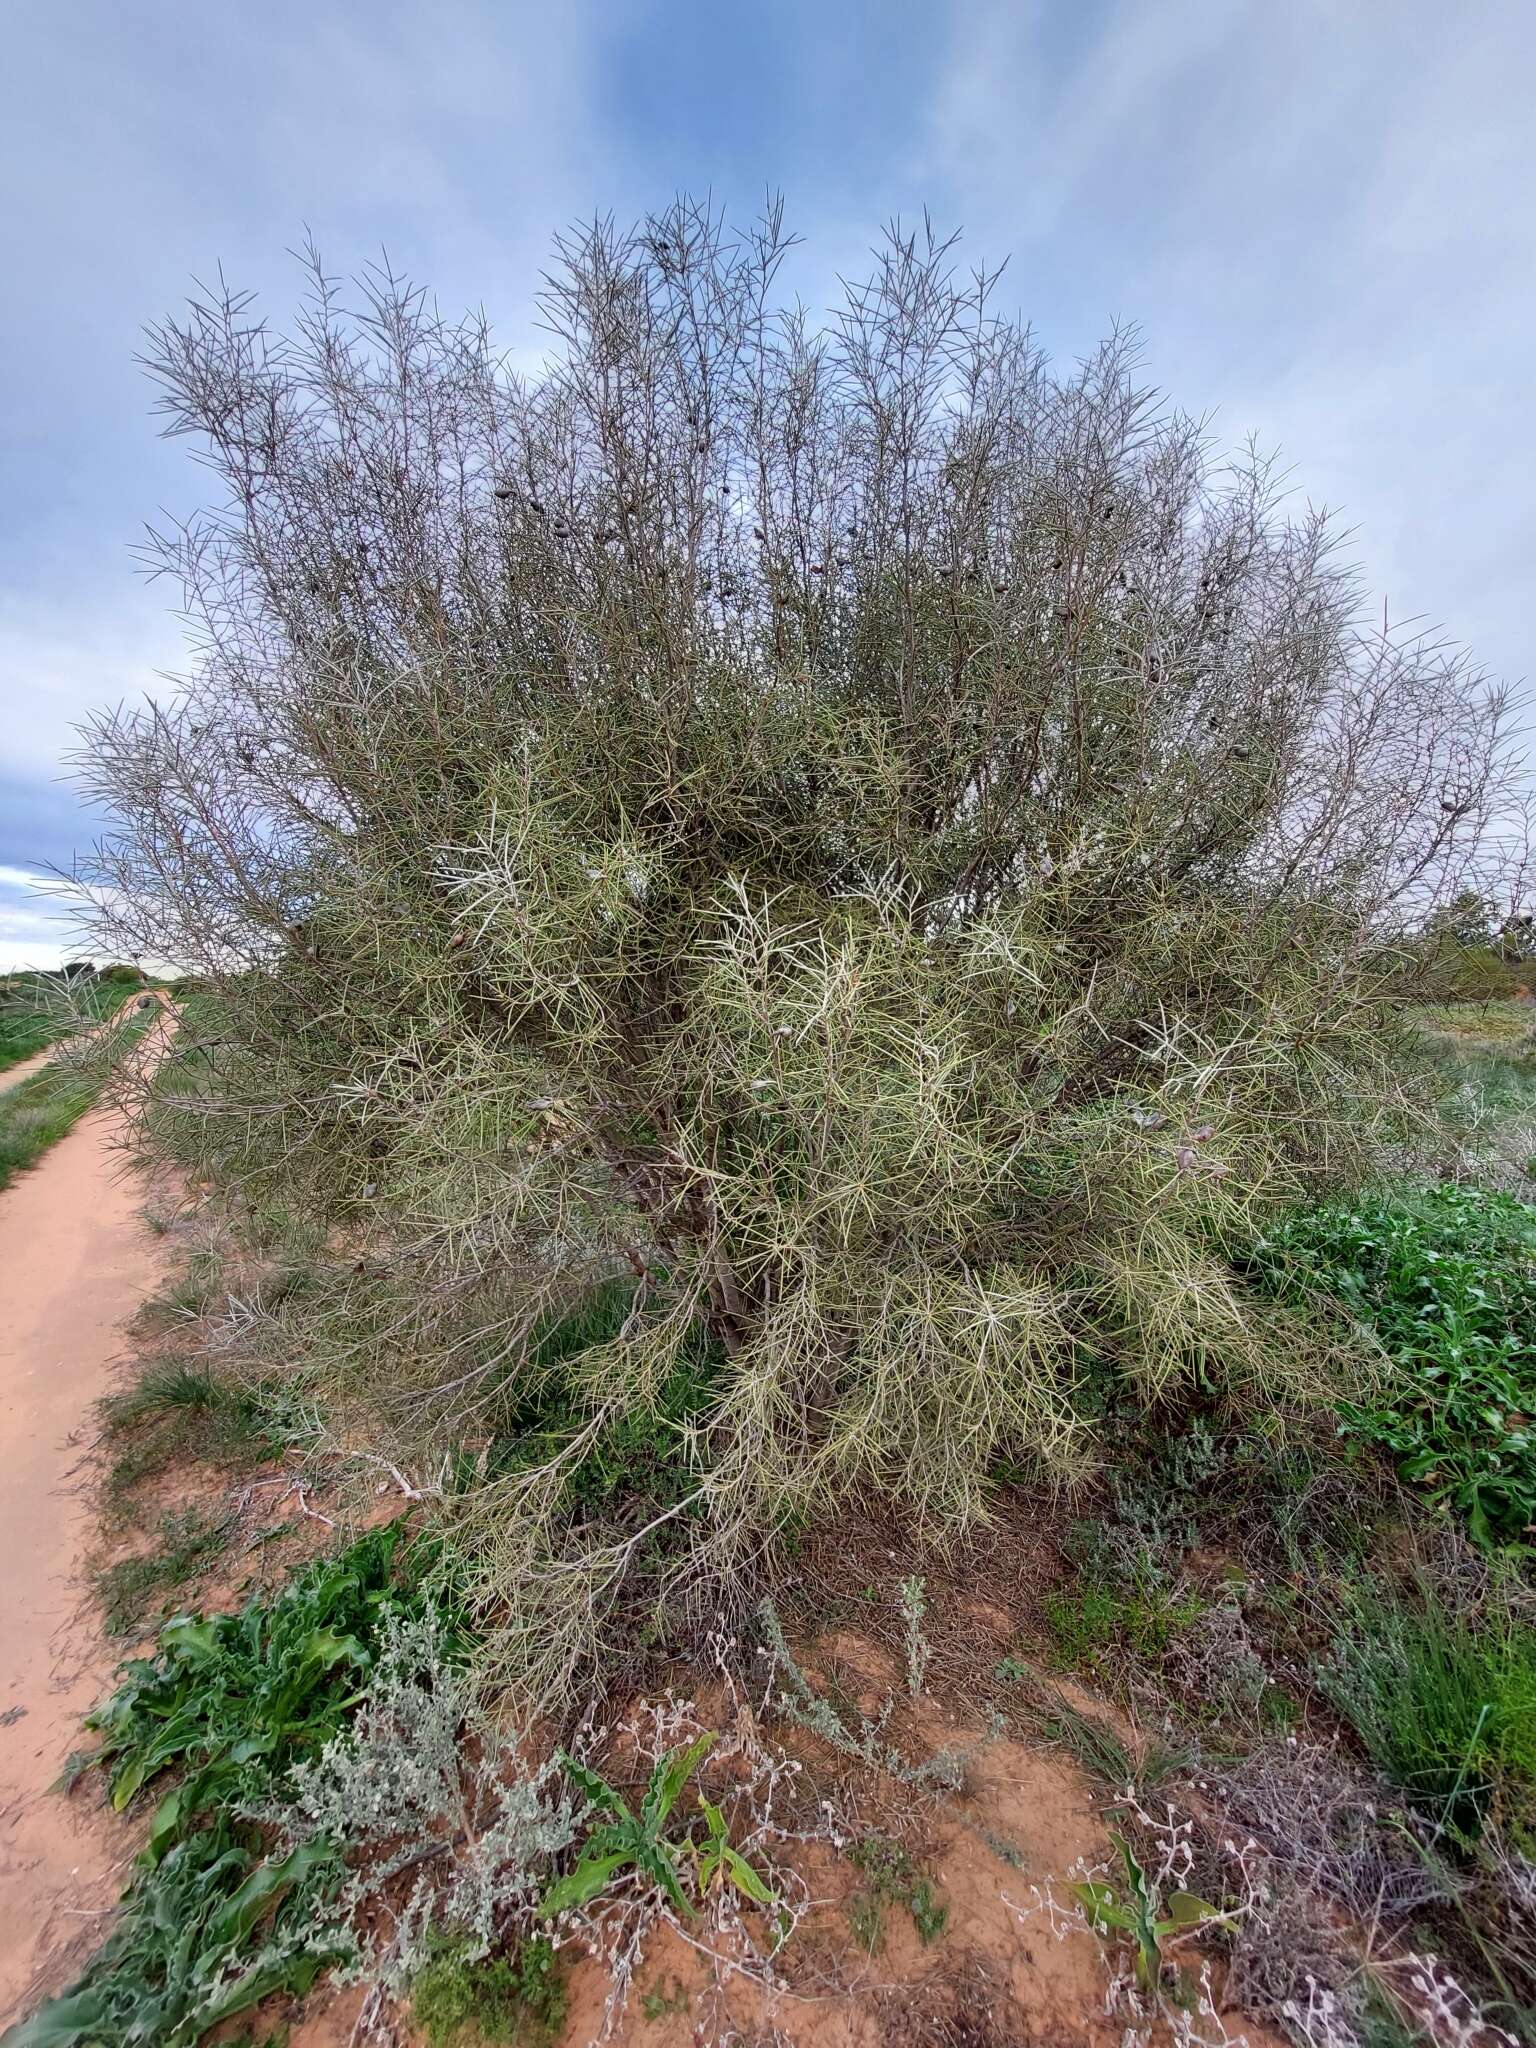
[0,1067,160,2023]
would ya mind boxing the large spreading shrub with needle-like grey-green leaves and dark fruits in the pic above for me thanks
[84,203,1507,1688]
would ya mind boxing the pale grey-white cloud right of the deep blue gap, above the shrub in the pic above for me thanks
[913,0,1536,704]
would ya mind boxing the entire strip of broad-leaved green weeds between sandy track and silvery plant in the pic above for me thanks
[18,1528,448,2048]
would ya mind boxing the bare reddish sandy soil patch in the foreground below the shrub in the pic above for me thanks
[289,1632,1286,2048]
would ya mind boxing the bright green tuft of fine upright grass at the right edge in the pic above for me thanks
[1317,1583,1536,1841]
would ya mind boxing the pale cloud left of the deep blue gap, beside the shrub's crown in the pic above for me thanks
[0,0,608,860]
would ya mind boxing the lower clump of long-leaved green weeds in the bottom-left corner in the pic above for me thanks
[6,1815,340,2048]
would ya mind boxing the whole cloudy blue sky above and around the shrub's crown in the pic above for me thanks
[0,0,1536,971]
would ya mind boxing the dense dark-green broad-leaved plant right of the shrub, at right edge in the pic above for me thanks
[1257,1184,1536,1542]
